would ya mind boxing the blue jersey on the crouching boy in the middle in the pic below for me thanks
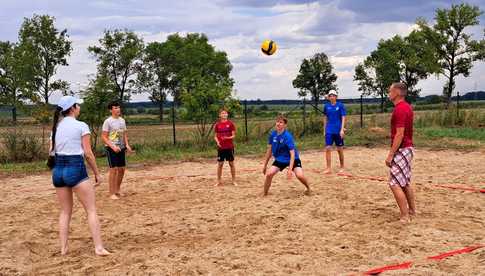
[268,130,300,164]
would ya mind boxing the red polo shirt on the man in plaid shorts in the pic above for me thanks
[391,101,414,148]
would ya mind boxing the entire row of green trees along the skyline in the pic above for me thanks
[0,4,485,128]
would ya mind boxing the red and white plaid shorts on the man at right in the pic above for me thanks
[389,147,414,188]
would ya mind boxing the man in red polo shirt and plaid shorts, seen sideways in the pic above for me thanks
[386,82,416,223]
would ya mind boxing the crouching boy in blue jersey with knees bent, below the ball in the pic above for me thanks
[263,116,310,196]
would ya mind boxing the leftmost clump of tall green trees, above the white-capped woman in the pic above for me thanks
[0,15,72,123]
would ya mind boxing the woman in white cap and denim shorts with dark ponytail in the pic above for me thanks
[51,96,110,256]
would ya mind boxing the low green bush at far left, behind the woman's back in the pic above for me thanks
[0,128,47,163]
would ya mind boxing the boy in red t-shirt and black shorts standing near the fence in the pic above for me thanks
[214,109,237,186]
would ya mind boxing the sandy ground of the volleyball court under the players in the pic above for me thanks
[0,148,485,275]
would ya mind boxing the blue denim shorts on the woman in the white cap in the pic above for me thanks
[52,155,89,188]
